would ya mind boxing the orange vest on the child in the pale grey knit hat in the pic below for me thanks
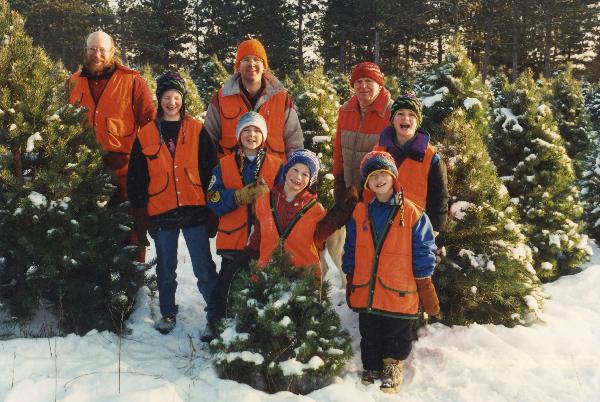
[217,153,281,251]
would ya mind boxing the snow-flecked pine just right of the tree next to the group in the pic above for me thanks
[491,71,591,281]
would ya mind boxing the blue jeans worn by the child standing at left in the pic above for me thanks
[151,225,217,321]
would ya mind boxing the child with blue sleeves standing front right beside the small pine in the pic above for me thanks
[342,151,439,393]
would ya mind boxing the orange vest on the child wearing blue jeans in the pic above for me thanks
[138,117,206,216]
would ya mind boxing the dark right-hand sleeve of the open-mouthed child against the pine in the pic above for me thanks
[425,154,450,232]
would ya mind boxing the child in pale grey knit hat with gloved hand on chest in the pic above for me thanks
[208,111,282,326]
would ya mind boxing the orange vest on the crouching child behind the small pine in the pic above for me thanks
[255,192,325,278]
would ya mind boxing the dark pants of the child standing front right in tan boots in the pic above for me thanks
[358,313,413,370]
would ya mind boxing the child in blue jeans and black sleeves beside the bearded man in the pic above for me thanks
[127,72,217,334]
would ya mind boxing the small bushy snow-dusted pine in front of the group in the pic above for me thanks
[210,247,352,393]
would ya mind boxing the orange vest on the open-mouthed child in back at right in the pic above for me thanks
[373,145,436,209]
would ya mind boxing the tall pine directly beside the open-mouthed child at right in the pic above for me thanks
[418,48,541,326]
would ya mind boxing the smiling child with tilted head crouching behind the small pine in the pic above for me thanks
[246,149,356,279]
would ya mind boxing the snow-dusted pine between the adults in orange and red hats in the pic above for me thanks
[286,68,340,208]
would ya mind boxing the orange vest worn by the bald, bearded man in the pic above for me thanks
[69,64,141,155]
